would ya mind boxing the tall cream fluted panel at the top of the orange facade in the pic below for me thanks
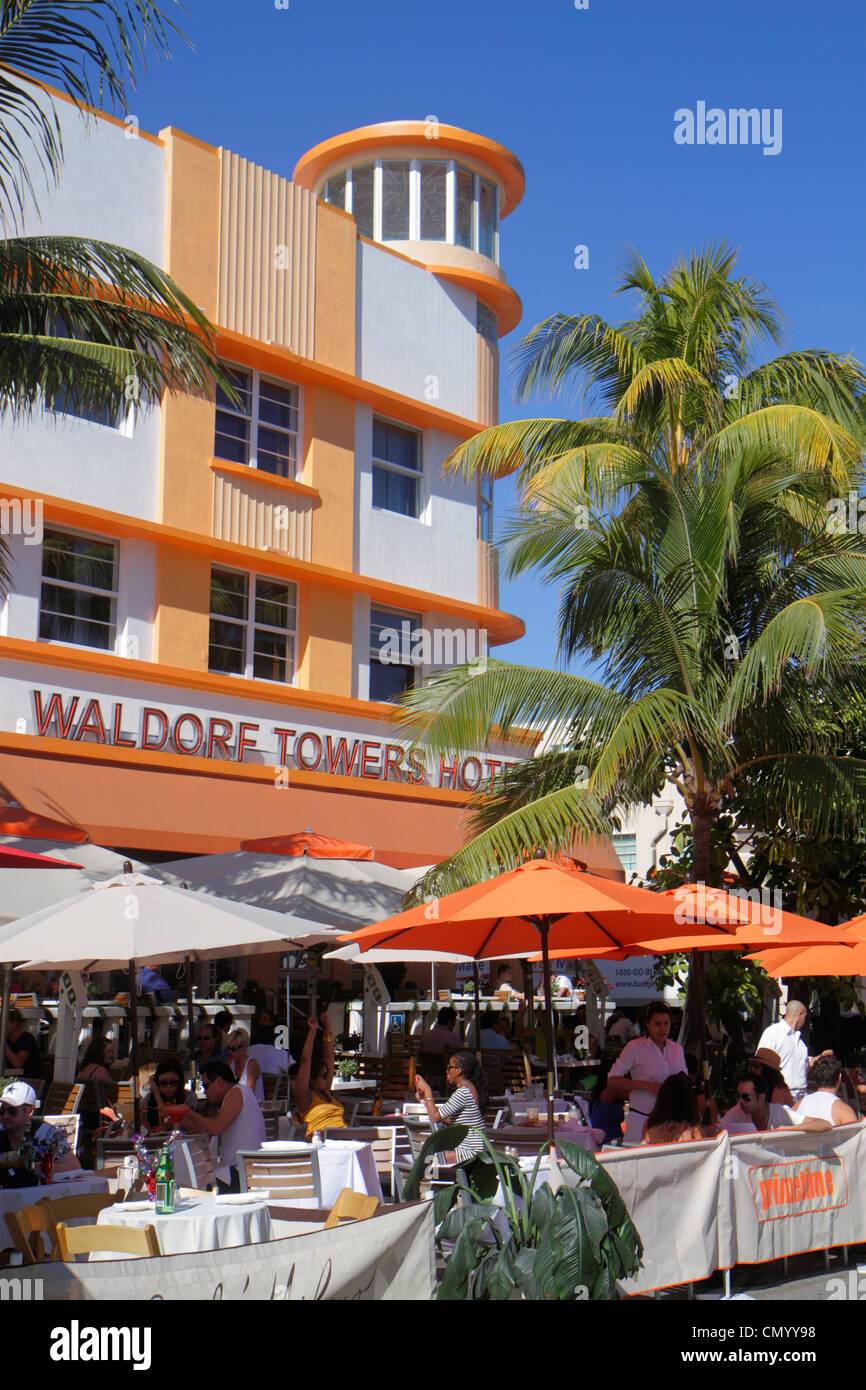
[218,150,316,357]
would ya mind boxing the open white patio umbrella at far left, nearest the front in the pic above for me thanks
[0,870,346,1126]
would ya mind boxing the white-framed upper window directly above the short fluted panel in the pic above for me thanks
[214,368,299,478]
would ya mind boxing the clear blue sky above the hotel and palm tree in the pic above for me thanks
[125,0,866,664]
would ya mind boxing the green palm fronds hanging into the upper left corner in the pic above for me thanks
[0,0,226,581]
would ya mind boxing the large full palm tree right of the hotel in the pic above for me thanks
[405,249,866,1045]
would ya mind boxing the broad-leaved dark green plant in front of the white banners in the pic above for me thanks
[403,1125,644,1302]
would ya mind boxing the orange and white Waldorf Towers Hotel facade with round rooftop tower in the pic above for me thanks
[0,103,547,865]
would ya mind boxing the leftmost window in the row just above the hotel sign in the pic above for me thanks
[39,531,117,652]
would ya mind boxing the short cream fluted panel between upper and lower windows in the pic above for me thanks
[213,470,314,560]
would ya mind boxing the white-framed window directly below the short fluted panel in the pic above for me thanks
[209,570,297,684]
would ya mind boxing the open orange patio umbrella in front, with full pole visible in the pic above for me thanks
[341,859,730,1143]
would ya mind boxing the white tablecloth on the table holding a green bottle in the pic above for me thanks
[90,1195,271,1259]
